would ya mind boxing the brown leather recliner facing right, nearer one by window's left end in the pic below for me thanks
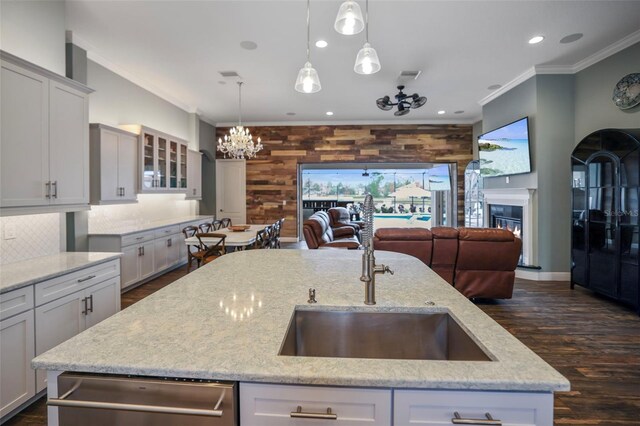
[302,211,360,249]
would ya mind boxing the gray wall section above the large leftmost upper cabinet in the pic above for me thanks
[0,0,65,75]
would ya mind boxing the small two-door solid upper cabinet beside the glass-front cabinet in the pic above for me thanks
[90,124,138,204]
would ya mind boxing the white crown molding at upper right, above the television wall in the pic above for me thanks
[478,30,640,106]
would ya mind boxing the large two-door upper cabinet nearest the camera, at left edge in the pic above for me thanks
[0,52,91,214]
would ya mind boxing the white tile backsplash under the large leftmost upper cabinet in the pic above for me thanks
[0,213,61,265]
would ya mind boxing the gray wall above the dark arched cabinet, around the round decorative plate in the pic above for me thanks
[575,43,640,144]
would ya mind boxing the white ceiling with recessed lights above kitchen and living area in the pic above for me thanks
[66,0,640,124]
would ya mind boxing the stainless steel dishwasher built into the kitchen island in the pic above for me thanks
[47,373,238,426]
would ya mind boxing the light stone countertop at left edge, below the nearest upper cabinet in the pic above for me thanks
[0,252,121,294]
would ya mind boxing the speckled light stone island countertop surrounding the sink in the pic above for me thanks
[32,250,569,392]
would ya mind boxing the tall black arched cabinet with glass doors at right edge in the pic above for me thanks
[571,129,640,309]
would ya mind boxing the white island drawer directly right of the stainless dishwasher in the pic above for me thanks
[240,383,391,426]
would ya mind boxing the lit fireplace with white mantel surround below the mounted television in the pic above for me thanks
[483,188,537,265]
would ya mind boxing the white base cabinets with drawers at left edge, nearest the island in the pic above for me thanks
[0,259,120,422]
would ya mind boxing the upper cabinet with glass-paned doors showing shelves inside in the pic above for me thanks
[140,127,188,192]
